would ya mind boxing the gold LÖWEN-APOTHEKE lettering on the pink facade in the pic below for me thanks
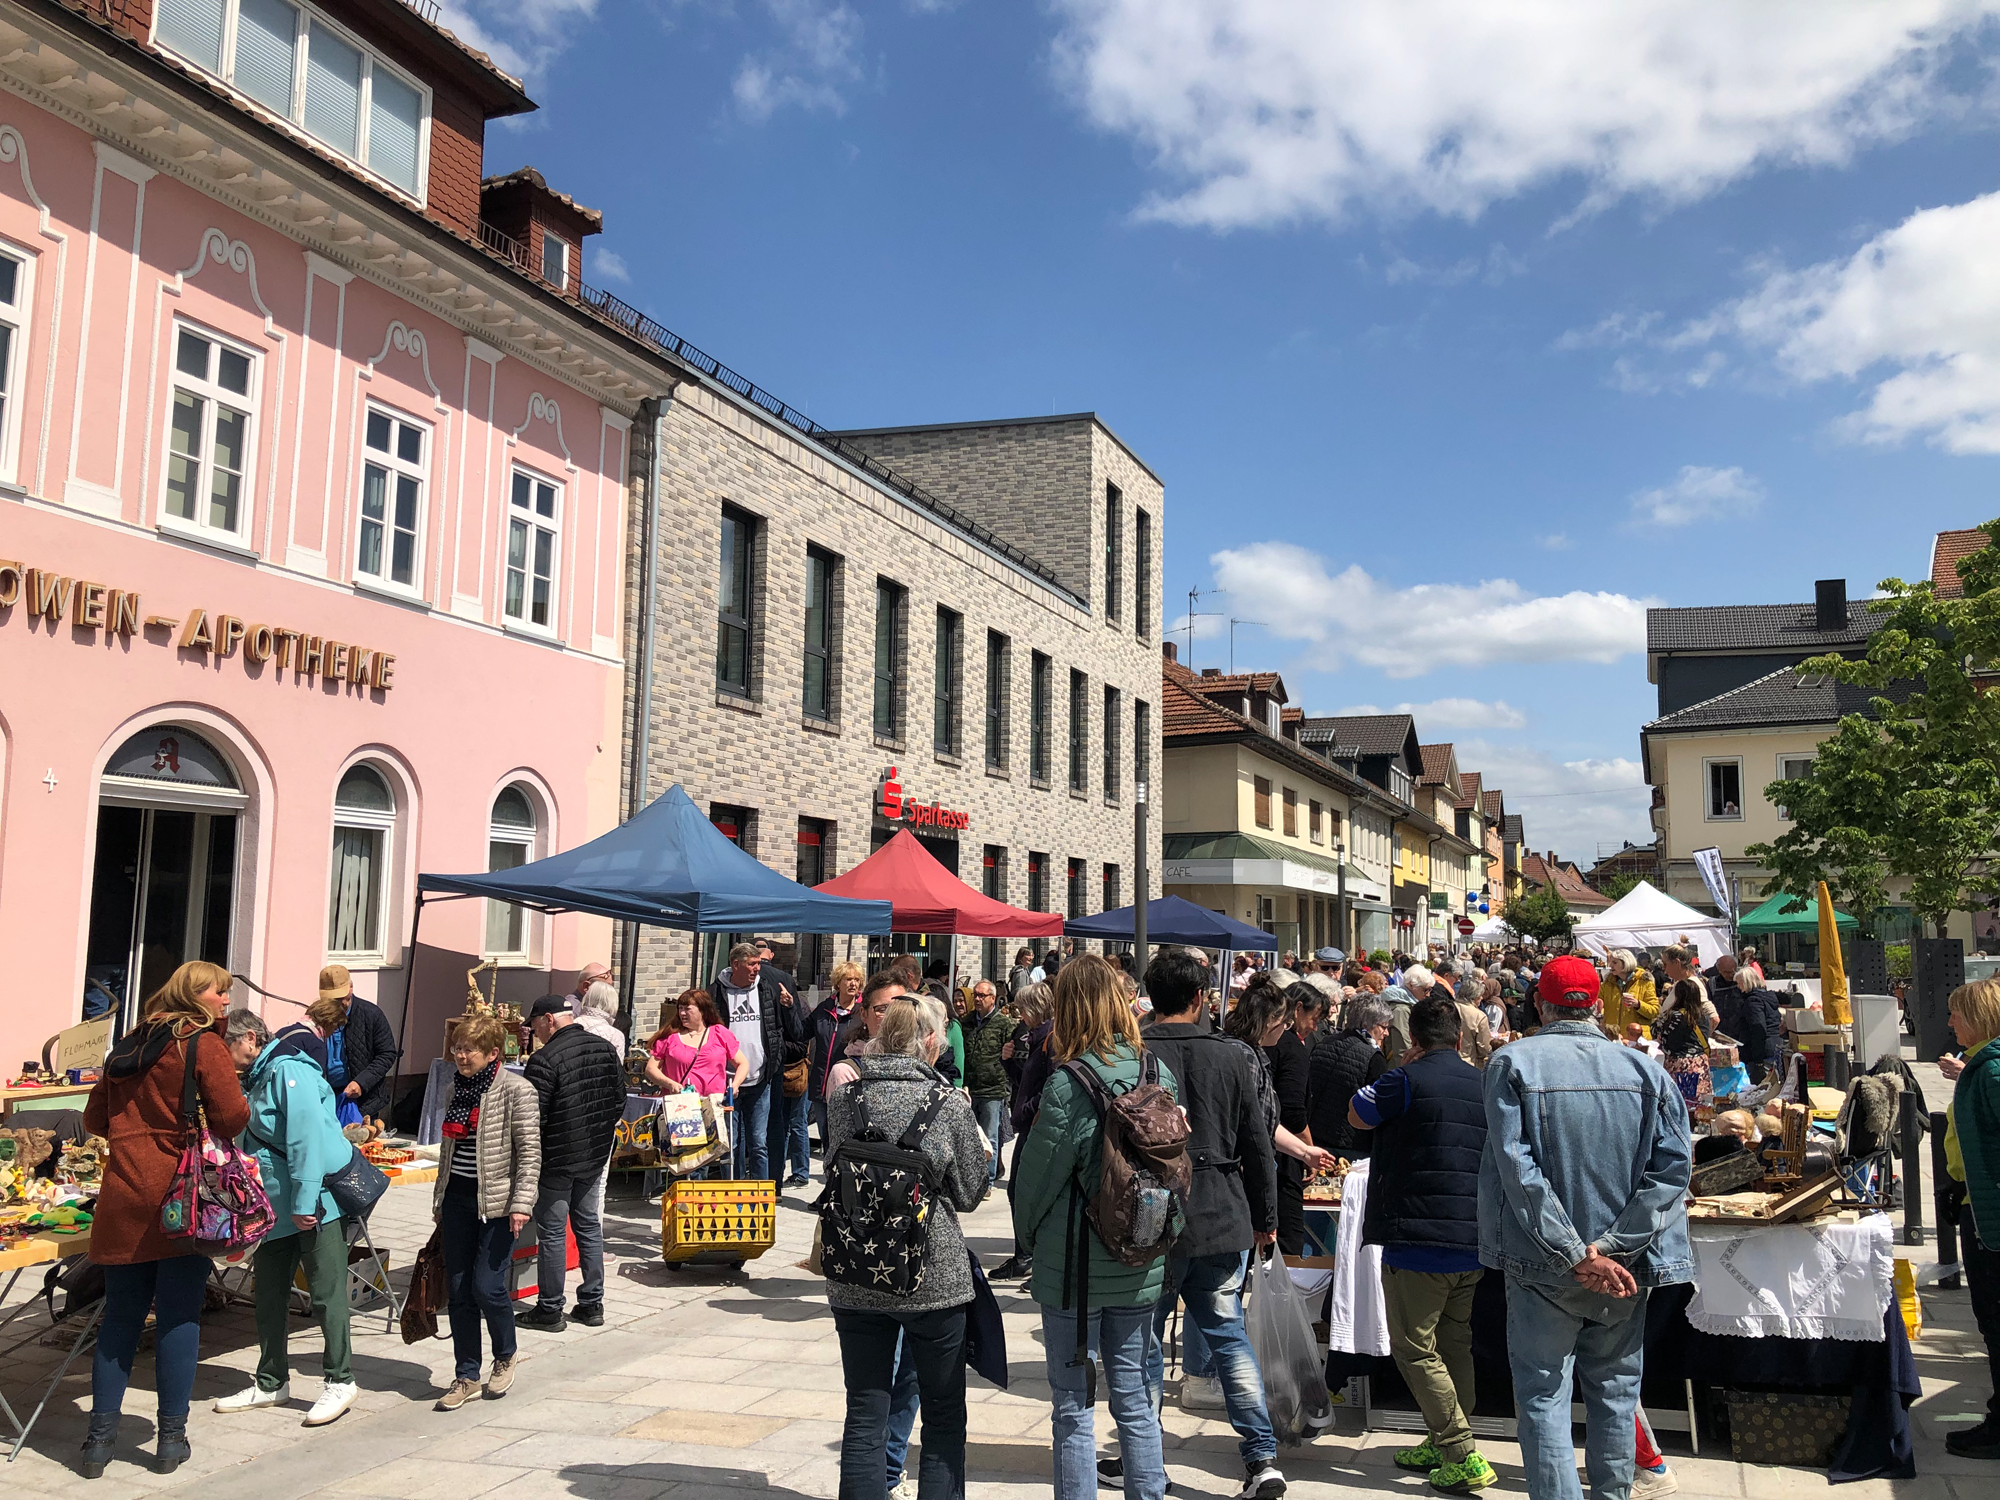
[0,558,396,692]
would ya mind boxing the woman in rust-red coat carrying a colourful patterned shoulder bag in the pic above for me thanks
[80,964,250,1480]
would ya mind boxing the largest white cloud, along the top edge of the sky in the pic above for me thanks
[1056,0,2000,228]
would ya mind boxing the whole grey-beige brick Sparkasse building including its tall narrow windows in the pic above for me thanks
[628,406,1164,1004]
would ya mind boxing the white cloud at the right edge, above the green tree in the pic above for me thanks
[1712,192,2000,454]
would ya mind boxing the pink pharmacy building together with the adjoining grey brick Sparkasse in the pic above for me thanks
[0,0,1164,1072]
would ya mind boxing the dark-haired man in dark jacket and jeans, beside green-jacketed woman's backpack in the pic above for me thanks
[1146,948,1284,1500]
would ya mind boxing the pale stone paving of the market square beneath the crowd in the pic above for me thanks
[0,1056,2000,1500]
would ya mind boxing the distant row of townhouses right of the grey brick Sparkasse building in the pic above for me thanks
[1160,642,1522,952]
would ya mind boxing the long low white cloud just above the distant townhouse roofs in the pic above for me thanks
[1210,542,1656,678]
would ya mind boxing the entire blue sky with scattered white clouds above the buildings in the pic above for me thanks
[446,0,2000,862]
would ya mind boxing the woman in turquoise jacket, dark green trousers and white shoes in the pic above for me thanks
[216,1010,360,1428]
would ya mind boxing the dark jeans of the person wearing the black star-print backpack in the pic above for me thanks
[834,1306,966,1500]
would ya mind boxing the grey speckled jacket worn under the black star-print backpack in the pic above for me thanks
[826,1052,986,1312]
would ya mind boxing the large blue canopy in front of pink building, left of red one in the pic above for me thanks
[416,786,890,934]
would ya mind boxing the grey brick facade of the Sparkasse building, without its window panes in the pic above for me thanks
[626,394,1164,1028]
